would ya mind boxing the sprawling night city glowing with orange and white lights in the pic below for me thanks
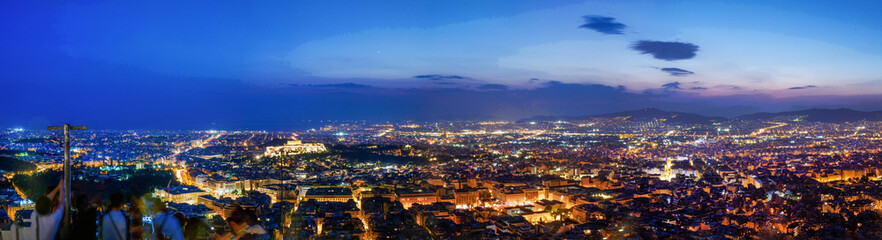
[0,109,882,239]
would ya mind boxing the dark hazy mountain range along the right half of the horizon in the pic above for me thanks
[518,108,882,124]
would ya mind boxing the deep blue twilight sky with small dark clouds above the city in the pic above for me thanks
[0,1,882,129]
